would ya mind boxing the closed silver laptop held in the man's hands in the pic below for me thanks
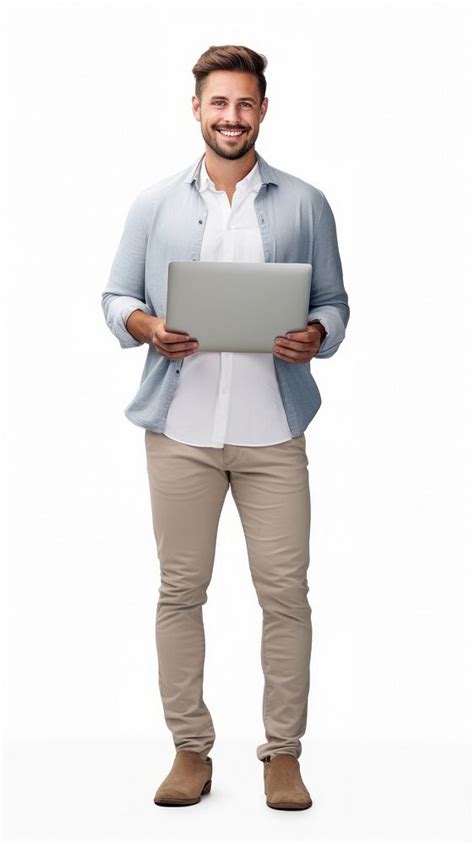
[166,261,313,352]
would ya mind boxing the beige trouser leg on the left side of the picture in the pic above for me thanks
[145,430,229,760]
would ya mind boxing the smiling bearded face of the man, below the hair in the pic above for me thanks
[193,70,268,159]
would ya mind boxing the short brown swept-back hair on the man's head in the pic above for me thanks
[193,44,267,102]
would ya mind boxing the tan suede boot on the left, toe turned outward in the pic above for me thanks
[154,750,212,806]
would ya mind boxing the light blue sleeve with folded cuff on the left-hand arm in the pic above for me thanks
[102,195,151,349]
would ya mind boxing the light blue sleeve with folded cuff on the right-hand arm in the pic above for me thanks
[308,194,350,358]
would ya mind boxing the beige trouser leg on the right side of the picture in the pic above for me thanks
[231,434,312,761]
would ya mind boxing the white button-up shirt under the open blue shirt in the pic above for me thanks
[163,158,292,448]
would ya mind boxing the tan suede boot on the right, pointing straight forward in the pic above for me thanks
[263,753,313,809]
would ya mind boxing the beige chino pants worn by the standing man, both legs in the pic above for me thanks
[145,429,312,762]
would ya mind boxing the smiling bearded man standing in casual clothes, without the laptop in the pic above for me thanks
[102,45,349,809]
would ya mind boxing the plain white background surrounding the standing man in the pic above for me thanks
[2,0,473,841]
